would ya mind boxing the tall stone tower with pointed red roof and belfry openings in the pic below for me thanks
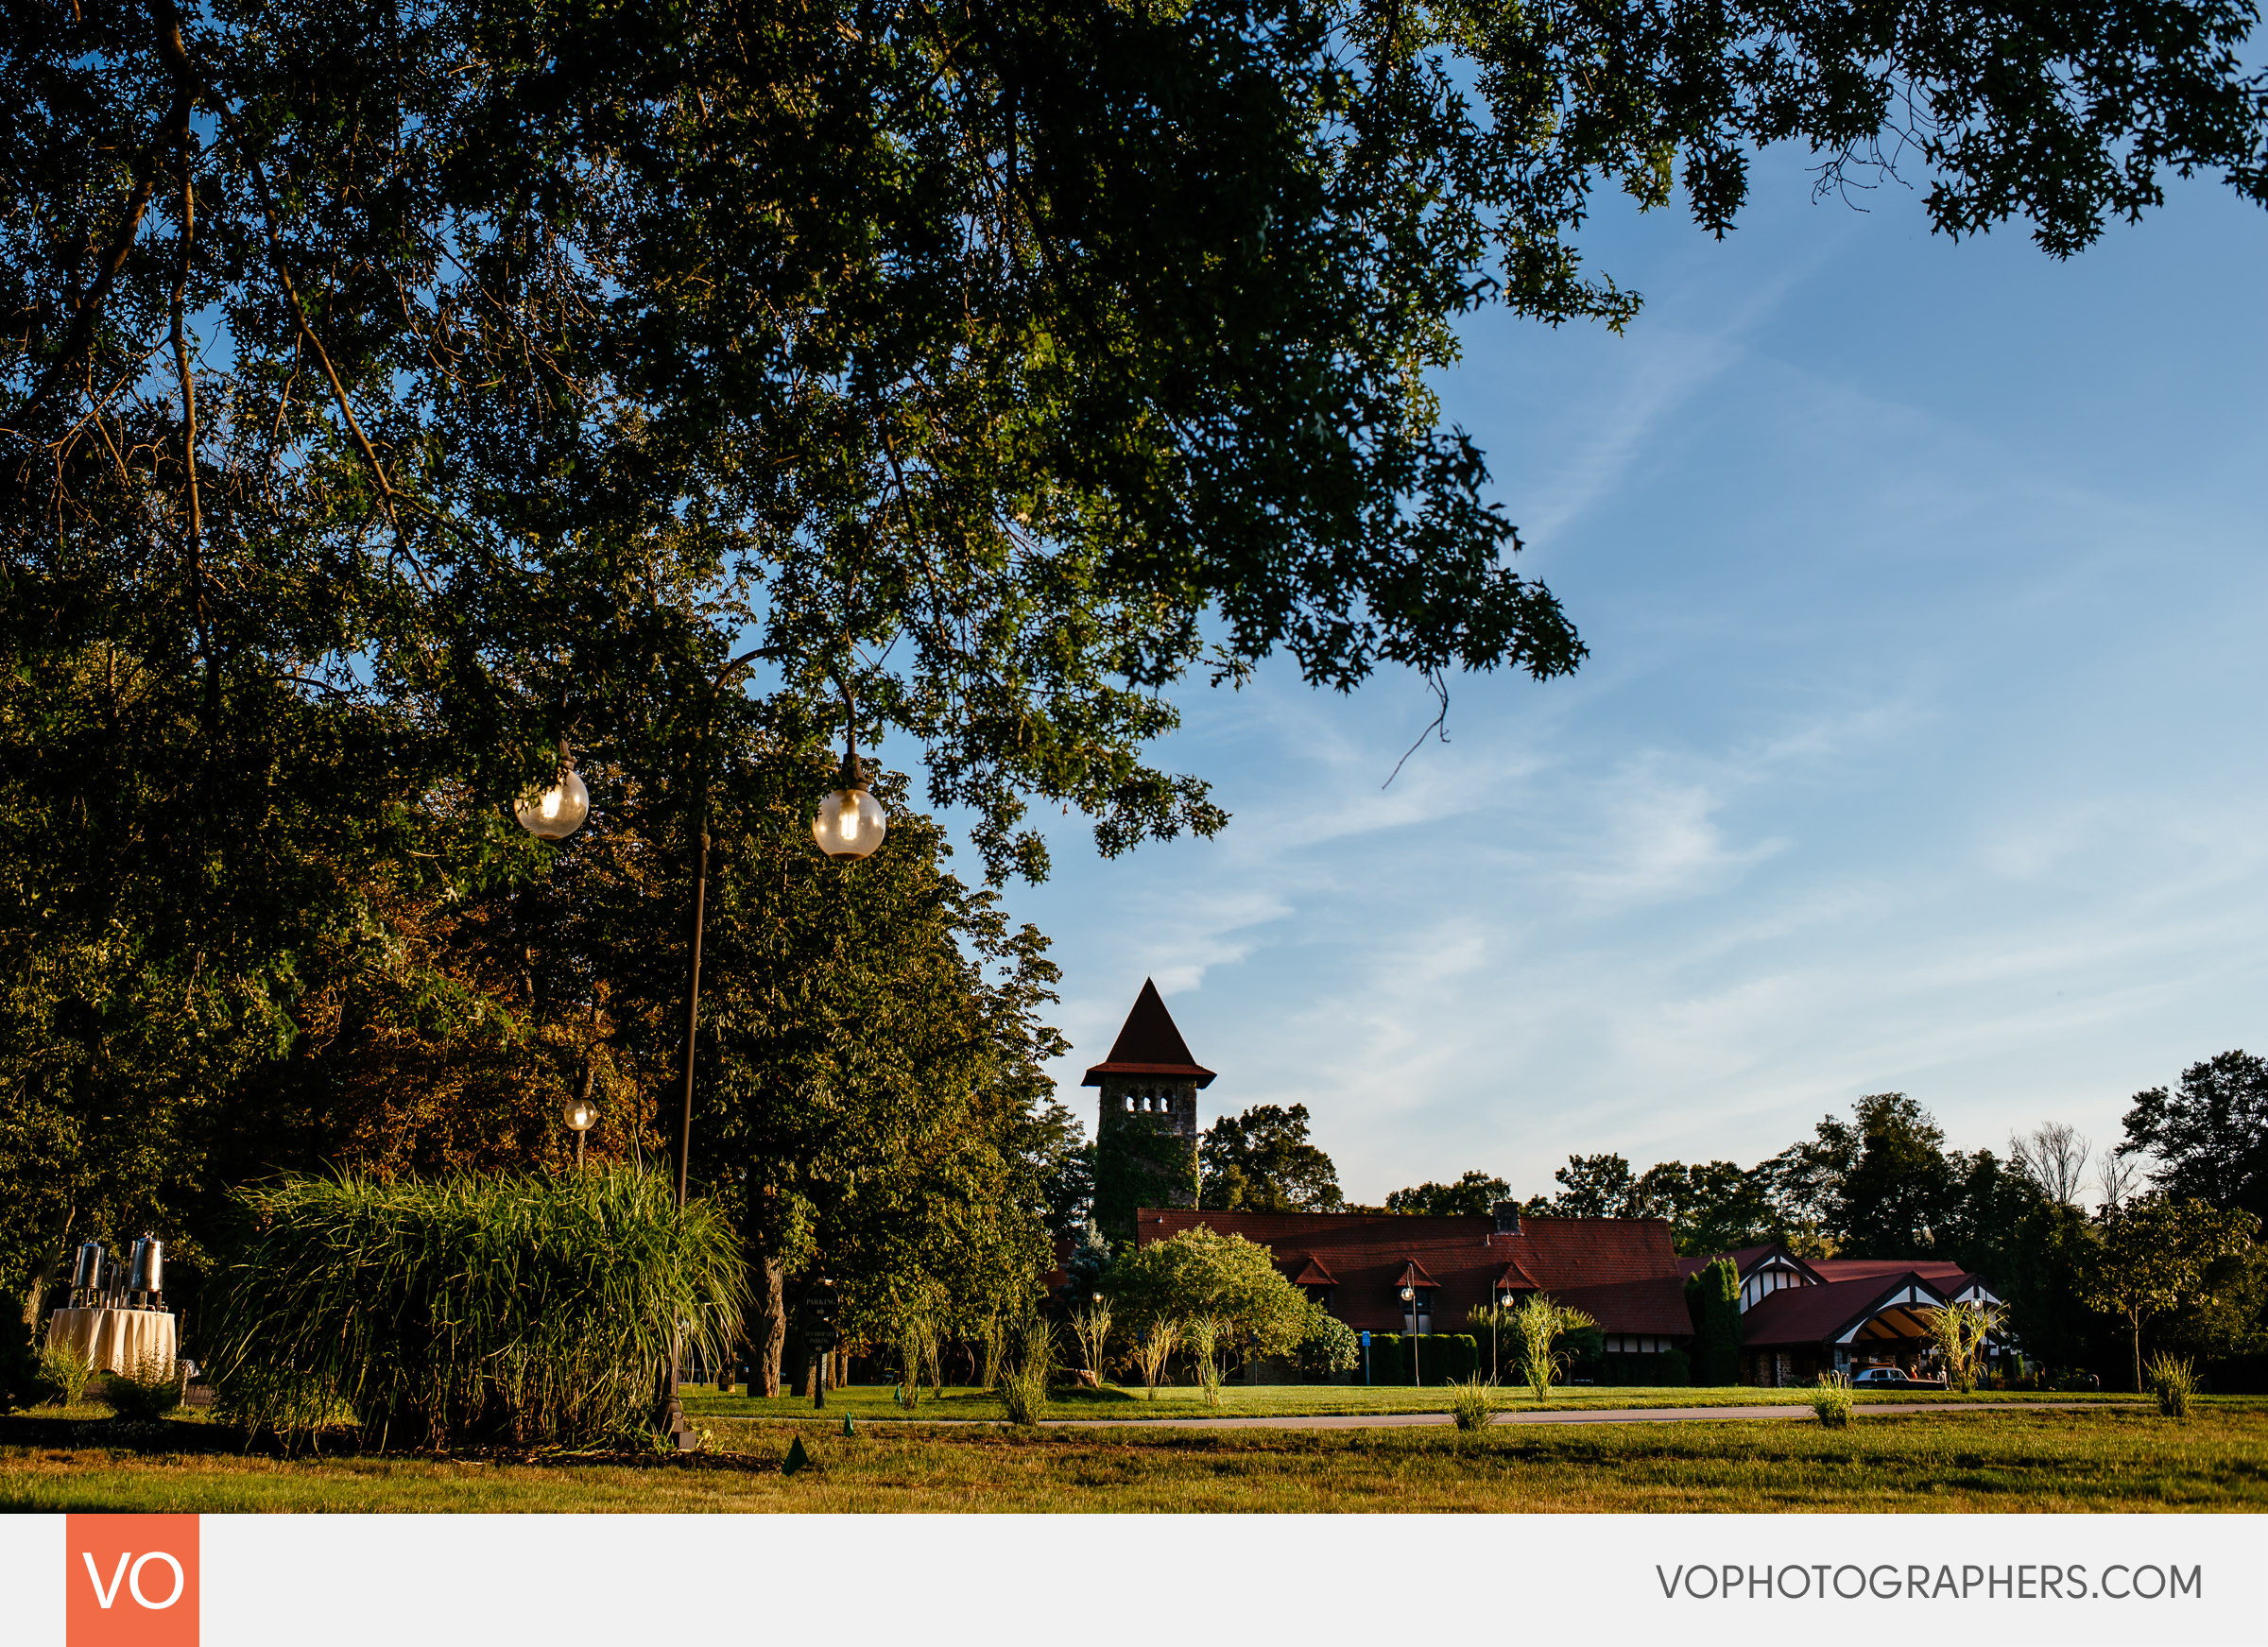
[1079,978,1213,1239]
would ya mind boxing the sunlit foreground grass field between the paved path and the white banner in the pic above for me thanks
[0,1393,2268,1513]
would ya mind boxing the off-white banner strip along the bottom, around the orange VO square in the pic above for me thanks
[0,1516,2268,1647]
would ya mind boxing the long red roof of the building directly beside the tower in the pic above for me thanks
[1136,1207,1692,1336]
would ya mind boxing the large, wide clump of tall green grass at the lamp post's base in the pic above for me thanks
[209,1168,747,1448]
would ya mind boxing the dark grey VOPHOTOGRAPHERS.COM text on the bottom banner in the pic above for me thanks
[1654,1561,2205,1602]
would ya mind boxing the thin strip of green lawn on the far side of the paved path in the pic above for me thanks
[685,1384,2141,1425]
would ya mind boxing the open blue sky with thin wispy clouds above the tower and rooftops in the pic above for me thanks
[1009,161,2268,1200]
